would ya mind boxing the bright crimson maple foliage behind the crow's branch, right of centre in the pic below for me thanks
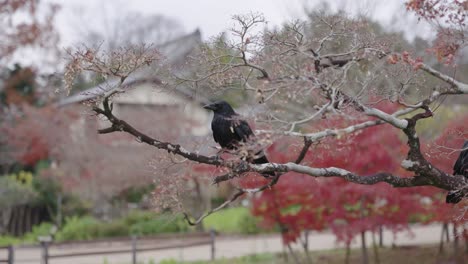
[252,100,458,243]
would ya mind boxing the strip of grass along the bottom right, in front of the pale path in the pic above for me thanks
[161,245,468,264]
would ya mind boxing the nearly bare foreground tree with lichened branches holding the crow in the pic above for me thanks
[63,1,468,231]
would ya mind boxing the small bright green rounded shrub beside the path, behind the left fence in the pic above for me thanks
[55,216,101,241]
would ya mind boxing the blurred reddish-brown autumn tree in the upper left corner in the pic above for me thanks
[0,0,58,172]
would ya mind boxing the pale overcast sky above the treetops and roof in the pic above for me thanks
[11,0,434,72]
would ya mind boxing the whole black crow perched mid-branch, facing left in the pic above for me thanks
[204,101,275,177]
